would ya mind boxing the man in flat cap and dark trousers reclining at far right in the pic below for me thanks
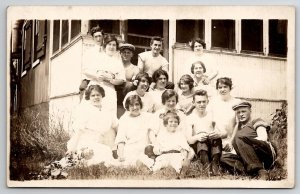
[221,101,276,180]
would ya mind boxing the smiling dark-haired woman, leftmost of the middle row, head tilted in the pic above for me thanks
[123,73,154,113]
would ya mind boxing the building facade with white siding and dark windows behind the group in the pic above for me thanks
[10,18,288,129]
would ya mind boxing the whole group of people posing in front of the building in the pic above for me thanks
[68,27,276,180]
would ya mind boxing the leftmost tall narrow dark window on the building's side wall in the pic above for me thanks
[23,20,32,71]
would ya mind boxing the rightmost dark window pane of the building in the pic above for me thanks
[269,20,288,57]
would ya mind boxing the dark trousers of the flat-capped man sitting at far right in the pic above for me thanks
[232,136,275,174]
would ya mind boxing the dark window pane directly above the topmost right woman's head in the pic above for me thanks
[176,20,205,43]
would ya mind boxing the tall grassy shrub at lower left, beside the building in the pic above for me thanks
[9,110,69,180]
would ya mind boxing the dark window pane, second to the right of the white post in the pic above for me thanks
[211,20,235,50]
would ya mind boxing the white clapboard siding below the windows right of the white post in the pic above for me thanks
[172,49,287,100]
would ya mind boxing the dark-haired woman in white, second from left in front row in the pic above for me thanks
[115,95,154,168]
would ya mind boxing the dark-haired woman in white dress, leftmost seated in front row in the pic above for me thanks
[67,85,118,165]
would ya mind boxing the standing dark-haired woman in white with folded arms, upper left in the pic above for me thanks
[83,35,125,114]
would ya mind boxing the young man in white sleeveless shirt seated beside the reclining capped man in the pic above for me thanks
[187,90,222,175]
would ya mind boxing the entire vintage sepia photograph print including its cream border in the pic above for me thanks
[6,6,295,188]
